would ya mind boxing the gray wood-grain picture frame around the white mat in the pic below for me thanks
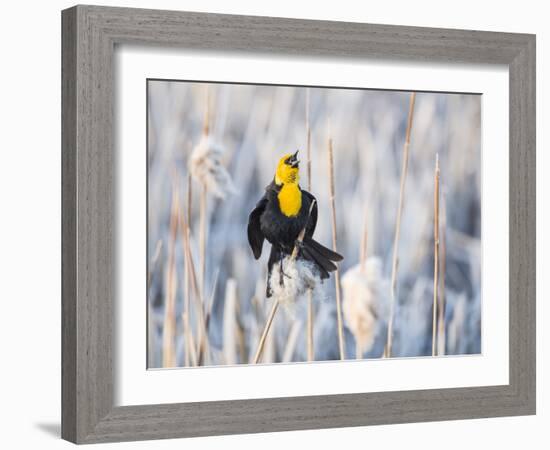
[62,6,536,443]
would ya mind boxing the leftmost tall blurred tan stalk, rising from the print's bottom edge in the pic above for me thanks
[162,181,179,367]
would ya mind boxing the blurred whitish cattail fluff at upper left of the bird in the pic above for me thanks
[189,135,235,199]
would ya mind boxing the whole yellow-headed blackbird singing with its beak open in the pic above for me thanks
[248,152,343,297]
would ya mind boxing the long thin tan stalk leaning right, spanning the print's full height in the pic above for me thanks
[384,92,416,358]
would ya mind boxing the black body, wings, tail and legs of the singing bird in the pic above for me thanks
[248,181,343,297]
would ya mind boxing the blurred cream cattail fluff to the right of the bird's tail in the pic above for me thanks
[342,257,384,355]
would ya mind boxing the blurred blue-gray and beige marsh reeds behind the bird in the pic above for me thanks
[147,80,481,368]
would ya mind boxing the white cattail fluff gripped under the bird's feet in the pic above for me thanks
[270,256,321,316]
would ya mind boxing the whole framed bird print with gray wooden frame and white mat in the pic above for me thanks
[62,6,536,443]
